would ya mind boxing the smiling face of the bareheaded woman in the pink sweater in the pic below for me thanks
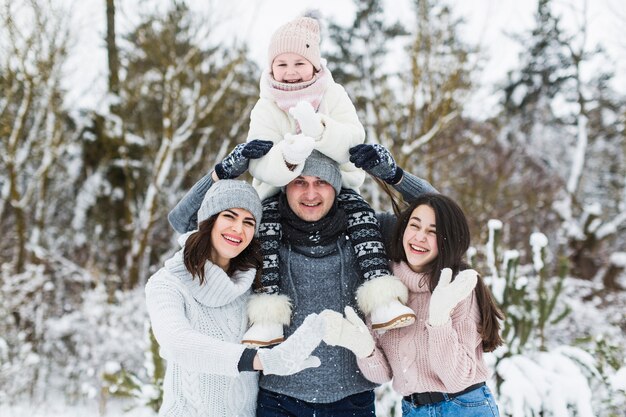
[402,204,439,272]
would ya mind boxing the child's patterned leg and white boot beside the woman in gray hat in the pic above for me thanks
[241,197,291,346]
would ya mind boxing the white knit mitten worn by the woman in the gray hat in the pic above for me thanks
[258,314,325,375]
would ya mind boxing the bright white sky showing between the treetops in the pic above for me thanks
[64,0,626,115]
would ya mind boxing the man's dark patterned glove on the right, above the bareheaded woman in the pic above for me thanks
[349,143,404,185]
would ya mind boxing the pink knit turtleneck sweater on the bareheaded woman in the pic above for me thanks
[358,262,489,395]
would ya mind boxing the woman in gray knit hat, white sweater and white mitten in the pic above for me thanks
[146,180,324,417]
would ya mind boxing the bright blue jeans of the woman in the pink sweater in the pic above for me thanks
[402,385,500,417]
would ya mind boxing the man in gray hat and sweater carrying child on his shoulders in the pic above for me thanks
[168,140,435,417]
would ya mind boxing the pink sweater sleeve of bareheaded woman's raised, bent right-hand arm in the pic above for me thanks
[426,293,485,392]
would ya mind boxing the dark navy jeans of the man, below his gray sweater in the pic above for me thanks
[256,389,376,417]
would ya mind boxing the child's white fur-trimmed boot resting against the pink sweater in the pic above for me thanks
[356,275,415,331]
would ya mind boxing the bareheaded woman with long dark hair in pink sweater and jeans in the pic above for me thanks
[322,194,504,417]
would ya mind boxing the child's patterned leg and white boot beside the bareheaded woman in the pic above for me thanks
[338,189,415,330]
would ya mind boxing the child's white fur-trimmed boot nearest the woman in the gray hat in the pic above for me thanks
[241,294,291,347]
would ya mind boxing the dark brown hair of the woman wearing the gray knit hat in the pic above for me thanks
[183,213,263,284]
